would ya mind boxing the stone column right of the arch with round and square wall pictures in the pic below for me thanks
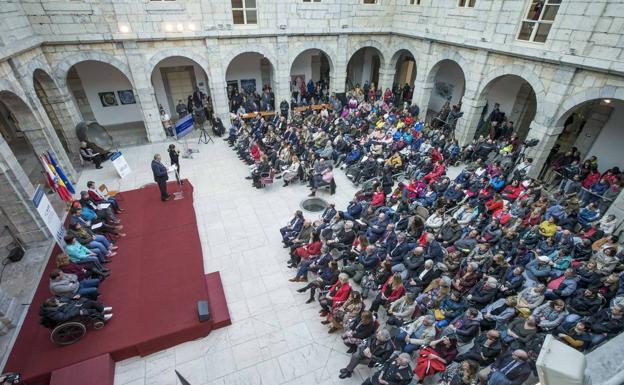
[123,41,166,142]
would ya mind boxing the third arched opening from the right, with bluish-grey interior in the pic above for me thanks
[426,59,466,123]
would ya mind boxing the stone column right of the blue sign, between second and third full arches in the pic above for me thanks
[204,39,230,123]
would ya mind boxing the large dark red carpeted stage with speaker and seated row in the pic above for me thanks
[5,181,230,385]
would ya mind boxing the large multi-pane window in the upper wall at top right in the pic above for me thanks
[518,0,561,43]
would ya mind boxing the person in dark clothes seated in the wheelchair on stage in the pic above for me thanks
[39,295,113,329]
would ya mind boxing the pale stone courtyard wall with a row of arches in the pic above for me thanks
[0,0,624,244]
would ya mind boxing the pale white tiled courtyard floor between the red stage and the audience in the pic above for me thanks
[79,131,376,385]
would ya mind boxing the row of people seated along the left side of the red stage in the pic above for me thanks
[39,181,126,329]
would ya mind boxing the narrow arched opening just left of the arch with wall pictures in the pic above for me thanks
[33,69,70,153]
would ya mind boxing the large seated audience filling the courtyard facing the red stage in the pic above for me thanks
[226,85,624,385]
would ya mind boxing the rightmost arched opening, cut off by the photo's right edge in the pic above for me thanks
[555,99,624,172]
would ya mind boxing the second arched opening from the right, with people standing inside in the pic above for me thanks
[475,75,537,139]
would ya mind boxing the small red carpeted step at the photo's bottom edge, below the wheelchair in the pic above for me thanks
[50,354,115,385]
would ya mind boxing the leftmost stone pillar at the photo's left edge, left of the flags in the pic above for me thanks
[0,137,48,244]
